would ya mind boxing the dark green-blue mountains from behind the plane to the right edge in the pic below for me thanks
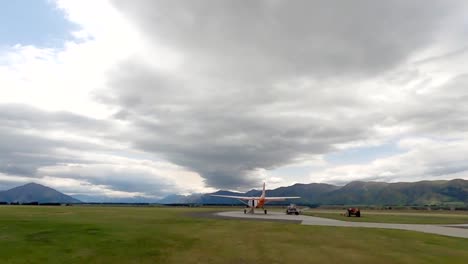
[158,179,468,205]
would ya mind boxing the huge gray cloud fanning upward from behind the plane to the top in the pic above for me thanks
[100,1,468,188]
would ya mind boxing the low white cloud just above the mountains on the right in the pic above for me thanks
[309,138,468,184]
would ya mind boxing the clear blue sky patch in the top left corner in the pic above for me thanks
[0,0,78,47]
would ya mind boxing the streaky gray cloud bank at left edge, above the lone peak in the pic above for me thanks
[0,104,111,177]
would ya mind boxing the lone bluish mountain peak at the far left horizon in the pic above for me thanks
[0,183,81,203]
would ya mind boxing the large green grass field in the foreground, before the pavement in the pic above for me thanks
[0,206,468,263]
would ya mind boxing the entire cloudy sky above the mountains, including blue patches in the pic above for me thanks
[0,0,468,198]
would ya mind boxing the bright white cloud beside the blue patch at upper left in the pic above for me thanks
[0,1,175,118]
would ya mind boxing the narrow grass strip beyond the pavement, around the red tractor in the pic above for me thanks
[303,210,468,224]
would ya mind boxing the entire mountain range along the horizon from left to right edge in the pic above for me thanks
[0,179,468,207]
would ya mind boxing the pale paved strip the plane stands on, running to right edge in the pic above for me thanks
[216,211,468,238]
